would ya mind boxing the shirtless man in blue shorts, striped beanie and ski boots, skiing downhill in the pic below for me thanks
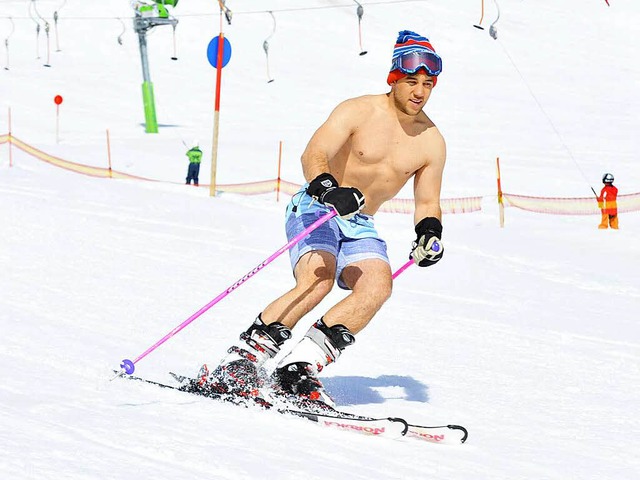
[199,30,446,404]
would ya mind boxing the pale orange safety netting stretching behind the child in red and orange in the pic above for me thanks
[502,193,640,215]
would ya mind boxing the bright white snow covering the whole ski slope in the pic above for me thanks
[0,0,640,480]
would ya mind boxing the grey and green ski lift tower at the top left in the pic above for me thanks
[132,0,178,133]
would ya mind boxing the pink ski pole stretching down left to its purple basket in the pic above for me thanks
[120,210,340,378]
